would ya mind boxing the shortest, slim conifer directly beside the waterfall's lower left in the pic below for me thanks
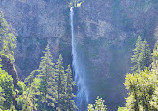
[65,65,77,111]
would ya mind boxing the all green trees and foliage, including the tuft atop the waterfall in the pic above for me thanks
[0,0,158,111]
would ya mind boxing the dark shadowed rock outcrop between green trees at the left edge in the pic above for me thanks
[0,56,18,87]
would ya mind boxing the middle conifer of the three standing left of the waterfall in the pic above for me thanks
[55,55,66,111]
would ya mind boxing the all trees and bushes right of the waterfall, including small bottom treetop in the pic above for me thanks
[88,36,158,111]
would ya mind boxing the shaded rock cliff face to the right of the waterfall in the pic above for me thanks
[75,0,158,111]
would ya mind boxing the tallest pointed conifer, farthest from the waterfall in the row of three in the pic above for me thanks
[38,45,56,110]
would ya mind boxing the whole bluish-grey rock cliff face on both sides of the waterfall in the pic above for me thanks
[0,0,158,110]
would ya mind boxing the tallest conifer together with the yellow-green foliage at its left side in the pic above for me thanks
[25,45,57,110]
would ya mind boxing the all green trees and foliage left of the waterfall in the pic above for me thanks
[0,12,77,111]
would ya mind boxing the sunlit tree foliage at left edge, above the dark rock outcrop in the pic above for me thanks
[0,12,16,62]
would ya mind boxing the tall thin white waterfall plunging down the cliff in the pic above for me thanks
[70,7,88,111]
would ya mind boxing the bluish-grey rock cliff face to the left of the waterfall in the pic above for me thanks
[0,0,71,79]
